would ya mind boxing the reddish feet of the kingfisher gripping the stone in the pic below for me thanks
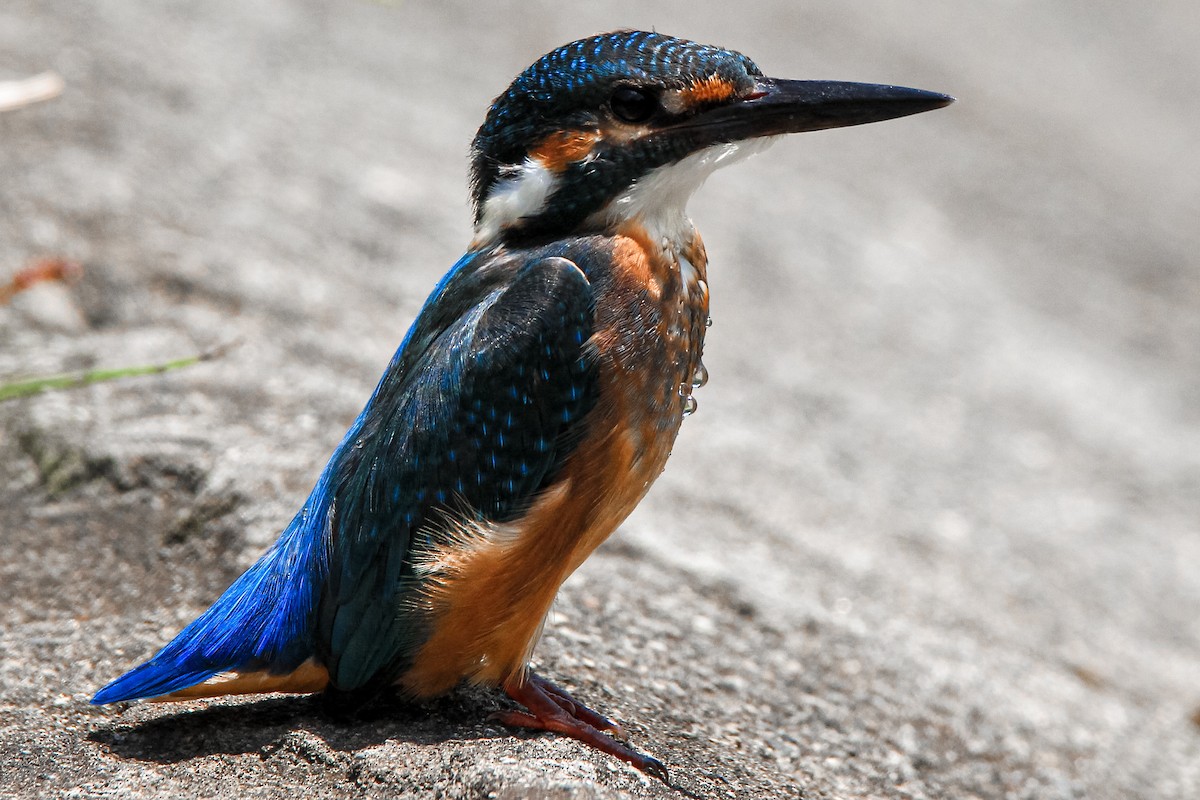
[491,672,670,783]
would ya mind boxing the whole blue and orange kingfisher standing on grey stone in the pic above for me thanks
[92,30,953,781]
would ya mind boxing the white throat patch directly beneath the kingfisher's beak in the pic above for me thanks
[600,137,776,241]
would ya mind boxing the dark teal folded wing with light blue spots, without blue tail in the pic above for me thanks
[316,257,596,694]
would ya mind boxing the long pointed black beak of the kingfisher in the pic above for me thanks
[676,78,954,144]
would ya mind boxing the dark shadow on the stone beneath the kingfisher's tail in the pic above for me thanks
[88,688,509,764]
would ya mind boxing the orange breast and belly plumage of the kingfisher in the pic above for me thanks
[398,227,708,696]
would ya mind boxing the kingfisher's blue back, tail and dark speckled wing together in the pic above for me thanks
[92,255,595,703]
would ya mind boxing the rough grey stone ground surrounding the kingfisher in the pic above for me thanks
[0,0,1200,799]
